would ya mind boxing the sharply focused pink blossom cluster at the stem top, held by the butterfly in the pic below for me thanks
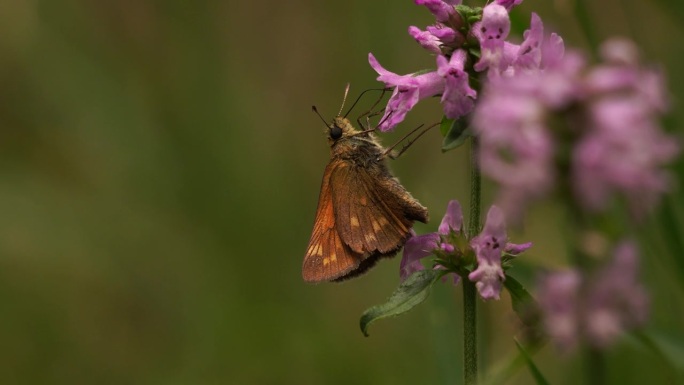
[368,0,536,131]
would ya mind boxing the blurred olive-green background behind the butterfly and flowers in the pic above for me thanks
[0,0,684,385]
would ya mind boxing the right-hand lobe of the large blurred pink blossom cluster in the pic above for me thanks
[573,40,680,216]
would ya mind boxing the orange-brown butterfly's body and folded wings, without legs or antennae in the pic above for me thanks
[302,117,428,282]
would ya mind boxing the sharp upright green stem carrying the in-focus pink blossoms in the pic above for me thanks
[462,136,482,385]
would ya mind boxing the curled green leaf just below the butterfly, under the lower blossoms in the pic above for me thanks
[360,269,447,337]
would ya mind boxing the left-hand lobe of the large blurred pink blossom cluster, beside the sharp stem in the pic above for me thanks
[472,73,555,222]
